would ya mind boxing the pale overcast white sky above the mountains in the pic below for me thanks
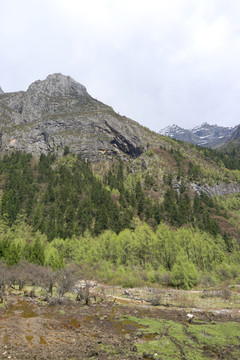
[0,0,240,131]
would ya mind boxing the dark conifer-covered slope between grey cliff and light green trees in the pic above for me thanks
[0,149,240,242]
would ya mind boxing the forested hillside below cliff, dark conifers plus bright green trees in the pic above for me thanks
[0,150,240,287]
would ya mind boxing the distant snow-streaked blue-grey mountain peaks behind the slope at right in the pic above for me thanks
[159,122,237,148]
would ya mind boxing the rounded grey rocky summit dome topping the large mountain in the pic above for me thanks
[27,73,87,96]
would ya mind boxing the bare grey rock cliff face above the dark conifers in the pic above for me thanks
[0,74,157,161]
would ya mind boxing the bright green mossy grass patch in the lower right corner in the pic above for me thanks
[121,317,240,360]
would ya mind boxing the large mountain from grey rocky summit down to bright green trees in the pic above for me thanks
[0,74,240,287]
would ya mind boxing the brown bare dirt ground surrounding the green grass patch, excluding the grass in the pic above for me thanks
[0,295,240,360]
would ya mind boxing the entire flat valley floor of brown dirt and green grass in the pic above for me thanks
[0,287,240,360]
